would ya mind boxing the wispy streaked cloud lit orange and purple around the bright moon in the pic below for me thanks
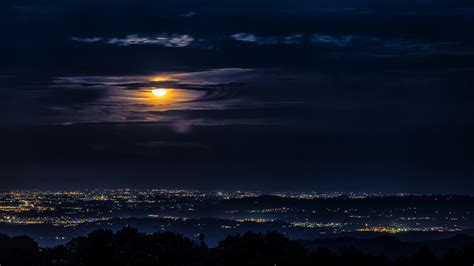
[46,68,265,123]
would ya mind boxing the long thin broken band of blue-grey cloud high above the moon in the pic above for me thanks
[71,32,474,58]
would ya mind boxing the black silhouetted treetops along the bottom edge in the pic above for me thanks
[0,227,474,266]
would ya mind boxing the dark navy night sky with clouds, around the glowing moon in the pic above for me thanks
[0,0,474,194]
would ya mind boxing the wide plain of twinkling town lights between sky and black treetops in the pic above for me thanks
[0,189,474,243]
